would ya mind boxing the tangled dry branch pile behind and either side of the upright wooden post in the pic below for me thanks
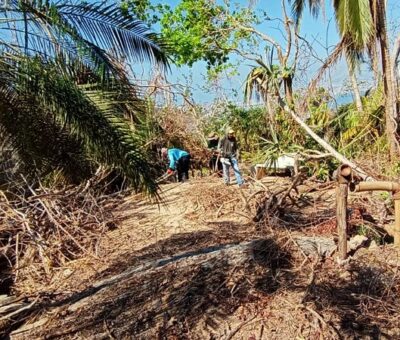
[246,174,391,237]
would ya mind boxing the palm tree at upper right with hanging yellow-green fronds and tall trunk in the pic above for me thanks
[292,0,399,157]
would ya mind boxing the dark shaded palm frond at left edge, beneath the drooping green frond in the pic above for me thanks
[0,69,91,184]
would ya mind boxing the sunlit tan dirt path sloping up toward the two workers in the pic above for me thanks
[13,179,260,339]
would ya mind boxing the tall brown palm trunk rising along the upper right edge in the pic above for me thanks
[377,0,399,159]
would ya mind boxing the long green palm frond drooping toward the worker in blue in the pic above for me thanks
[0,59,157,195]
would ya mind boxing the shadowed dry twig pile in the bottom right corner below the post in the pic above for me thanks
[302,247,400,339]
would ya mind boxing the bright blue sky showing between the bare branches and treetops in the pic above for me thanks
[140,0,400,104]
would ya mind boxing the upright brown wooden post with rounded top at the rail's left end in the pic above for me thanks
[336,165,351,260]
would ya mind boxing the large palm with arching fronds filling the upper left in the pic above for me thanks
[0,0,167,194]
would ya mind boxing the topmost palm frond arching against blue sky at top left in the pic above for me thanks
[0,0,168,76]
